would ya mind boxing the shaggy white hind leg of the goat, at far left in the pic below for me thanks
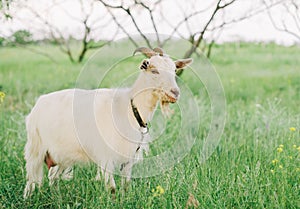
[24,115,45,198]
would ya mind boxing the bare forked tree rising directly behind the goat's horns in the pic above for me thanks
[99,0,236,64]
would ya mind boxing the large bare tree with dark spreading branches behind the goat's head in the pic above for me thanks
[99,0,280,68]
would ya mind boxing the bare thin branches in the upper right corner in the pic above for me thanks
[263,0,300,43]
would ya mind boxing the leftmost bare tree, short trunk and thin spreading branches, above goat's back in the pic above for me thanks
[10,0,117,63]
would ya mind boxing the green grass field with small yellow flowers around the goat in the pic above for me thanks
[0,43,300,208]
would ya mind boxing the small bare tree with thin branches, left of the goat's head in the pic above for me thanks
[7,0,116,63]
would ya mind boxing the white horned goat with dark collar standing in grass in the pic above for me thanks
[24,47,192,198]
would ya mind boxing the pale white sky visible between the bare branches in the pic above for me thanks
[0,0,299,45]
